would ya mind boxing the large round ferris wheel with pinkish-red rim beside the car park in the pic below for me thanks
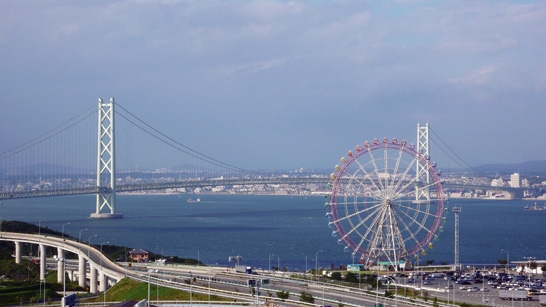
[325,138,447,269]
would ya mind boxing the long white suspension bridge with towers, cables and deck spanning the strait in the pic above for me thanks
[0,98,515,218]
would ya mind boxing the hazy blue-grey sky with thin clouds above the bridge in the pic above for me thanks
[0,0,546,169]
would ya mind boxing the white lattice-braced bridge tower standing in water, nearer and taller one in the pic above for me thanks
[91,98,123,219]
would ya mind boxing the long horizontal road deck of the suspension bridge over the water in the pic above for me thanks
[0,176,523,200]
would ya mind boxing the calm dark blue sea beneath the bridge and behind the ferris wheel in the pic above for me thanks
[0,194,546,271]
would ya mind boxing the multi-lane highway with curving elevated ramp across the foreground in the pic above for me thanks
[0,232,539,307]
